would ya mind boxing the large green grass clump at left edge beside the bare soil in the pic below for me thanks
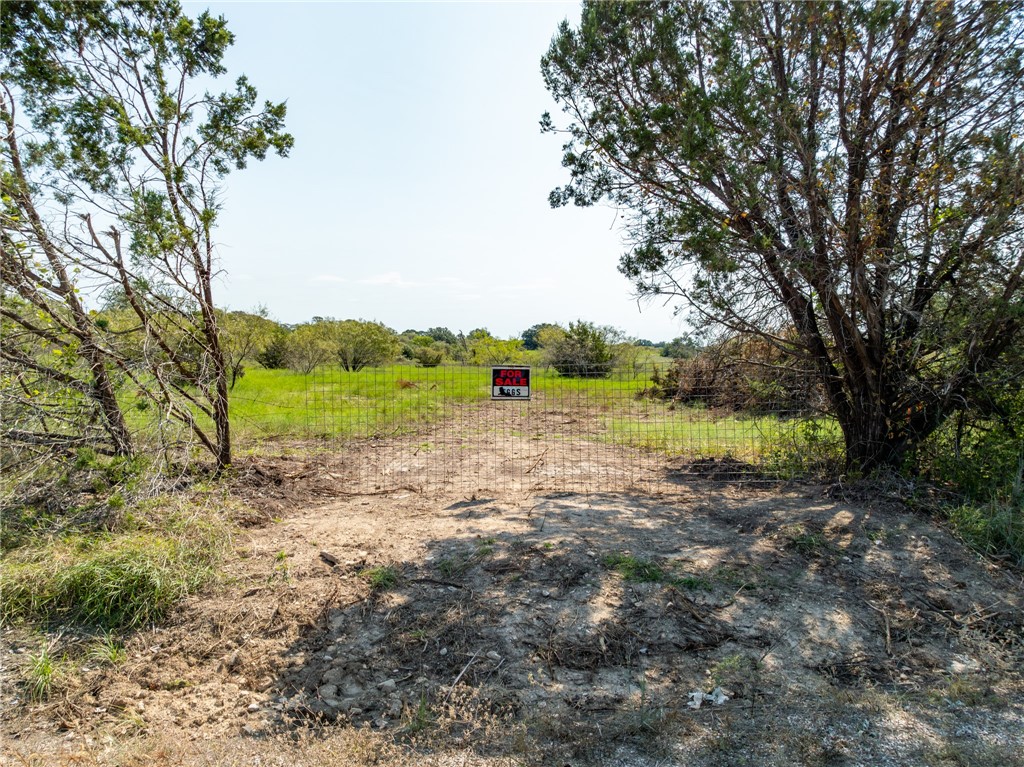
[0,501,227,631]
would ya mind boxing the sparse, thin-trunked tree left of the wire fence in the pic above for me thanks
[0,0,292,467]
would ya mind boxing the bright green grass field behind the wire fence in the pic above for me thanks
[218,364,840,471]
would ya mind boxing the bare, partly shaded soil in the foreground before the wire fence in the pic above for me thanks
[0,423,1024,767]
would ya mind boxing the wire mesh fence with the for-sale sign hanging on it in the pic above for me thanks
[233,365,839,496]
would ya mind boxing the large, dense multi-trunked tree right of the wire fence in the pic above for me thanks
[542,2,1024,471]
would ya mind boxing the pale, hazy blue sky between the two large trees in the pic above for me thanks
[190,2,685,341]
